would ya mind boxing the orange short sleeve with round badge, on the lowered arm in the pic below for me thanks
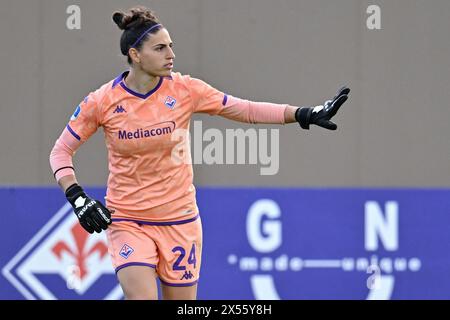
[67,92,100,142]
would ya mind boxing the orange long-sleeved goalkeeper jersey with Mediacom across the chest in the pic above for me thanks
[57,72,287,222]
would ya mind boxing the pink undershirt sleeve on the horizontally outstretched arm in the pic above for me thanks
[219,96,288,124]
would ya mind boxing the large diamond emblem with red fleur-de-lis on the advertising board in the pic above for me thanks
[2,203,123,300]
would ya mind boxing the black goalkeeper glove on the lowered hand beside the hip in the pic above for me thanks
[66,183,111,233]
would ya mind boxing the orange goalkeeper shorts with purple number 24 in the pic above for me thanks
[106,216,202,286]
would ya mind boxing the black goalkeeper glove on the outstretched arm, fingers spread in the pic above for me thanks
[295,87,350,130]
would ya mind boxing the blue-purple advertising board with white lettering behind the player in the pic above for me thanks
[0,188,450,300]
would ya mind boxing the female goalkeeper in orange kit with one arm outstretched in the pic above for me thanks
[50,7,350,300]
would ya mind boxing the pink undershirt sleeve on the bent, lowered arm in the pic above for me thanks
[50,128,82,181]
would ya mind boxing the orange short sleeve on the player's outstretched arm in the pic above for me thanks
[189,78,228,115]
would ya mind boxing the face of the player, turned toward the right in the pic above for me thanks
[139,29,175,77]
